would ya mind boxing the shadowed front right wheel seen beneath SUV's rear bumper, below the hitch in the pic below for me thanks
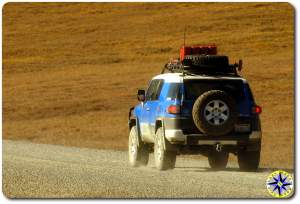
[208,151,229,170]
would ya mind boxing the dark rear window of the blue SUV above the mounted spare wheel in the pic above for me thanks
[184,79,244,100]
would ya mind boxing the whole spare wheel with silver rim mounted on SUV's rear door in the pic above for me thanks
[192,90,238,136]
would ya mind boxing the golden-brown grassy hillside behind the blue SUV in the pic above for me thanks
[2,3,295,168]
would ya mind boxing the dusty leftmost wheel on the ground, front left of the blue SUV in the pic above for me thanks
[128,126,149,167]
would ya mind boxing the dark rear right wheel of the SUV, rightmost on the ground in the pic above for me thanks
[237,142,260,171]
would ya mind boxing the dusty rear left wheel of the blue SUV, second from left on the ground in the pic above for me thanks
[154,128,176,170]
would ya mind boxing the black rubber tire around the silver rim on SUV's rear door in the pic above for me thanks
[192,90,238,136]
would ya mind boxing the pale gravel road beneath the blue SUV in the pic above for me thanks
[3,140,290,198]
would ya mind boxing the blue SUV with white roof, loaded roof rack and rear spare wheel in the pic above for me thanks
[128,45,261,171]
